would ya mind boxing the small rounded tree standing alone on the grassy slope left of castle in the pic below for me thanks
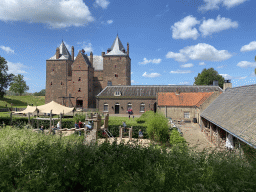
[10,74,29,96]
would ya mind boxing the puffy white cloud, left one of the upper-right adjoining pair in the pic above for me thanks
[171,15,200,40]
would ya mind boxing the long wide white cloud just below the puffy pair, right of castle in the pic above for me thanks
[166,43,232,62]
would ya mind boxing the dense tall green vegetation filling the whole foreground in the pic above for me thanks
[0,127,256,191]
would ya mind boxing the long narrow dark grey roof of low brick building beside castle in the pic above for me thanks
[97,85,222,98]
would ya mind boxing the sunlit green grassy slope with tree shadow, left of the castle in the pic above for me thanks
[0,95,45,108]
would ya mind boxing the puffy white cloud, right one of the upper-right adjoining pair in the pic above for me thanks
[199,15,238,37]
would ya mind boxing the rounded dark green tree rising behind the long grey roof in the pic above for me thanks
[194,68,224,88]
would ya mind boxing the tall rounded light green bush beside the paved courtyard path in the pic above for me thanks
[147,113,169,143]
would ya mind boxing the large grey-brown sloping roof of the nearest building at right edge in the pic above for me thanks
[201,85,256,148]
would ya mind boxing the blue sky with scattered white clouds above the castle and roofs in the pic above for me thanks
[0,0,256,92]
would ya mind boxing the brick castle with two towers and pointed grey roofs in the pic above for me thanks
[45,35,131,108]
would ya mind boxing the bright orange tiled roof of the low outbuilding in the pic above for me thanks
[157,92,214,107]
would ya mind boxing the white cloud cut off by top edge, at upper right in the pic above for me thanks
[199,0,247,11]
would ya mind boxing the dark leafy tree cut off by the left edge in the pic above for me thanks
[0,56,14,98]
